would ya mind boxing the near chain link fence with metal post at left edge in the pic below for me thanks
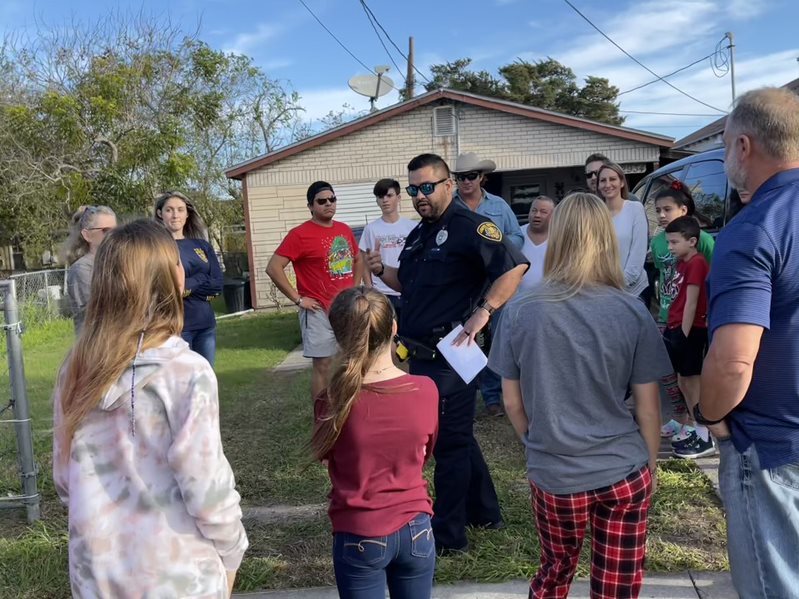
[0,279,39,522]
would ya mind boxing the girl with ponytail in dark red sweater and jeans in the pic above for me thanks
[311,287,438,599]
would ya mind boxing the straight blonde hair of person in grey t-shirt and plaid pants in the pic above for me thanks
[542,193,625,299]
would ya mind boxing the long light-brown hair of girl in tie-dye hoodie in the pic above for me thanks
[56,219,183,455]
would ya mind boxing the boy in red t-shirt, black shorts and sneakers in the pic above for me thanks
[663,216,716,458]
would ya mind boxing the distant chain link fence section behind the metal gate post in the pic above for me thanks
[9,268,70,329]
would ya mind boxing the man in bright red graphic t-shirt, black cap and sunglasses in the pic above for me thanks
[266,181,361,397]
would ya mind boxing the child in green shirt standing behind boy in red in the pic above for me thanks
[650,180,714,442]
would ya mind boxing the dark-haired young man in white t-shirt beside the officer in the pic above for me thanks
[358,179,417,320]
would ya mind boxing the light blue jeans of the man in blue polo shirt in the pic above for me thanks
[719,440,799,599]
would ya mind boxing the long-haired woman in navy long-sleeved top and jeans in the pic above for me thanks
[155,191,222,366]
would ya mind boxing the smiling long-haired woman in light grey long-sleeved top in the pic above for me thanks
[597,162,649,300]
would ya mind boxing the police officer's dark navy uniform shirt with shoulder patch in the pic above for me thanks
[397,202,530,342]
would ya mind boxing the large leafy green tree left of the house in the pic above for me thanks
[0,17,302,254]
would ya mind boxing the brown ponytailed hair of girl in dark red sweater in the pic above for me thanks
[311,286,394,460]
